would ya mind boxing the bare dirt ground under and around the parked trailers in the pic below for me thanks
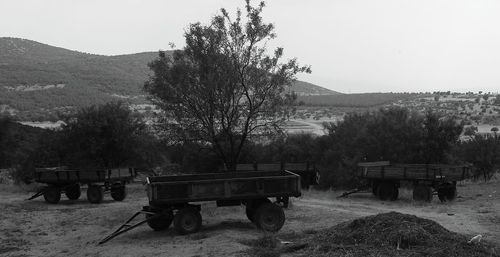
[0,180,500,257]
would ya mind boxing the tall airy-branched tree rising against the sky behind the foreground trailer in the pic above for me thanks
[144,0,310,170]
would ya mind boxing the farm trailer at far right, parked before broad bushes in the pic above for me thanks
[341,162,472,202]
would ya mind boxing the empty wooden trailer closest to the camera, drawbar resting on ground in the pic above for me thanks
[99,171,301,244]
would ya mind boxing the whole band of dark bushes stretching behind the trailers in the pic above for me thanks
[0,102,500,188]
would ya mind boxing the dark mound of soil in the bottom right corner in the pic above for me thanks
[303,212,500,257]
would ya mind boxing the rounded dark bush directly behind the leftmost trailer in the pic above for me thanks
[61,102,152,167]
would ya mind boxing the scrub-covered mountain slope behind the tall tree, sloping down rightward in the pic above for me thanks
[0,37,338,120]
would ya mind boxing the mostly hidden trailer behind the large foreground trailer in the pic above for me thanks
[236,162,320,189]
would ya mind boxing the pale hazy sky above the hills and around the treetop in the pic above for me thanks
[0,0,500,93]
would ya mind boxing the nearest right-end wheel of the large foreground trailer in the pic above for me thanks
[254,203,285,232]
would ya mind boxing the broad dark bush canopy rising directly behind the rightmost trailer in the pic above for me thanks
[327,108,463,164]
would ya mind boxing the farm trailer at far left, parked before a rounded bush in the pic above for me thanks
[28,167,136,204]
